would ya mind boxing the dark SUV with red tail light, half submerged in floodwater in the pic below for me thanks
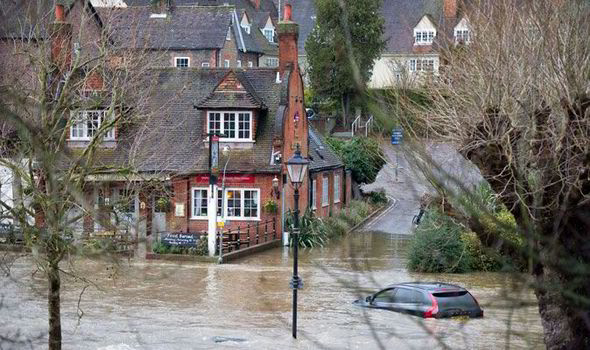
[354,282,483,318]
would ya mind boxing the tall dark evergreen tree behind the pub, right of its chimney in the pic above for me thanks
[305,0,385,119]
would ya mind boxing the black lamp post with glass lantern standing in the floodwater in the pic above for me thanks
[287,145,309,338]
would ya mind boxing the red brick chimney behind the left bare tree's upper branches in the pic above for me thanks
[51,4,72,72]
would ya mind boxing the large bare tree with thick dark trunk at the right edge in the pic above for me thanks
[402,0,590,349]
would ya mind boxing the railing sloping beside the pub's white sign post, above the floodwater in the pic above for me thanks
[215,218,278,253]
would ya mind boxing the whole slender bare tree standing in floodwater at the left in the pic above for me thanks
[0,1,169,349]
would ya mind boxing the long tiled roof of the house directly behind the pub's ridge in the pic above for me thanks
[97,6,234,49]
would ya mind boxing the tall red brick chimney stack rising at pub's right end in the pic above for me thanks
[278,4,299,75]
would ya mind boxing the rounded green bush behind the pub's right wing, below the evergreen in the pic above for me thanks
[326,137,385,183]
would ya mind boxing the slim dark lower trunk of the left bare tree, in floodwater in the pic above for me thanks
[47,262,61,350]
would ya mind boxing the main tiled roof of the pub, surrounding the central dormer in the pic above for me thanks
[93,68,281,175]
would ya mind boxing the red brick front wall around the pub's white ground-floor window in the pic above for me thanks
[168,174,281,238]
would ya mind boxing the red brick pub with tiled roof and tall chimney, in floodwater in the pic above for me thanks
[47,5,351,255]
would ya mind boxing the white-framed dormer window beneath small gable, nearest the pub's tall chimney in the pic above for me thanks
[207,111,252,141]
